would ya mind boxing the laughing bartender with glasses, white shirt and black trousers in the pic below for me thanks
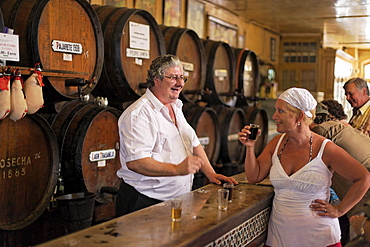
[116,55,237,216]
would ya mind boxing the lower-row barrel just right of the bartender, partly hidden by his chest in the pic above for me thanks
[183,103,221,165]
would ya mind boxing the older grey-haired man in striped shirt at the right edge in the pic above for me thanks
[343,77,370,136]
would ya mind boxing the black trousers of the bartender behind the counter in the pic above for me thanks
[116,180,162,217]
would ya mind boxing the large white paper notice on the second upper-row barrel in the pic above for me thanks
[129,21,150,50]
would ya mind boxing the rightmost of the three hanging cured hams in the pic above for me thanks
[23,64,44,114]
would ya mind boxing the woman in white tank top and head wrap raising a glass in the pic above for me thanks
[239,88,370,247]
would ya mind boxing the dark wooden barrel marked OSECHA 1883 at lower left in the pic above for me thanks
[0,114,59,230]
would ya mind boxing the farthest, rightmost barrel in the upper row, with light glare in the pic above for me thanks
[234,49,260,101]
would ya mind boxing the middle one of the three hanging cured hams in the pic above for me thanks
[9,69,27,121]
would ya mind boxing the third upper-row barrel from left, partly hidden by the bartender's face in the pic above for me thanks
[160,25,206,103]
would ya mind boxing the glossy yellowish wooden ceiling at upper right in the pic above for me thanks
[208,0,370,49]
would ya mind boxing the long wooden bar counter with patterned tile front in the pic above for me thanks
[38,173,273,247]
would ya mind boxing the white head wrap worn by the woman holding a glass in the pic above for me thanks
[279,87,317,117]
